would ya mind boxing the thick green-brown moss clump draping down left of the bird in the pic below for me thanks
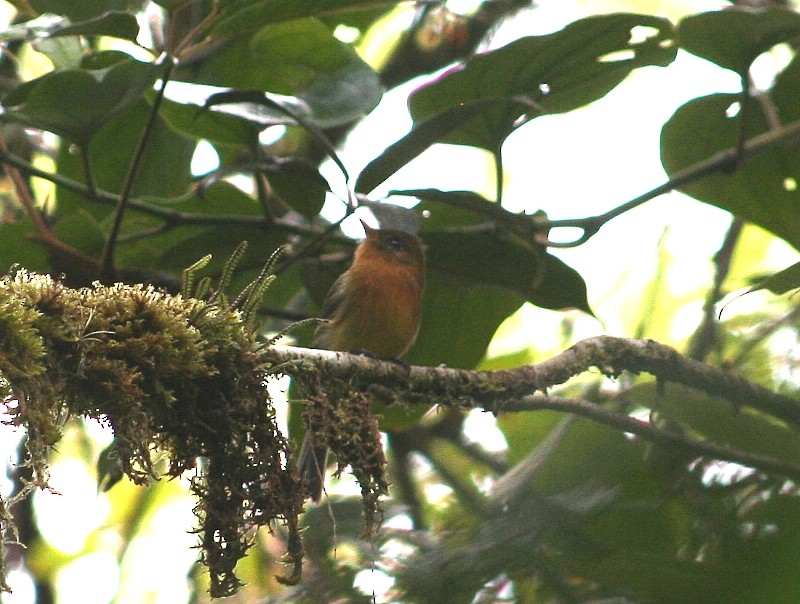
[0,271,303,597]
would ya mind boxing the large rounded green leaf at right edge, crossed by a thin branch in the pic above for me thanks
[661,91,800,247]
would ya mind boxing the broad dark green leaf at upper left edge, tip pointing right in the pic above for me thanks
[3,54,161,145]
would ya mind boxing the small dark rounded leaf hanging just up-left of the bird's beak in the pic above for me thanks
[266,158,330,220]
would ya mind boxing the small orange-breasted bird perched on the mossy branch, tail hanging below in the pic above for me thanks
[298,220,425,502]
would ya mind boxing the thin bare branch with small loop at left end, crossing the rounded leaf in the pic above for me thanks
[540,121,800,247]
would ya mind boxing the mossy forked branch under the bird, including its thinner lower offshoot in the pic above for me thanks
[265,336,800,480]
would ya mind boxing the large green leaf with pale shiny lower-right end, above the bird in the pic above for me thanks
[181,19,383,128]
